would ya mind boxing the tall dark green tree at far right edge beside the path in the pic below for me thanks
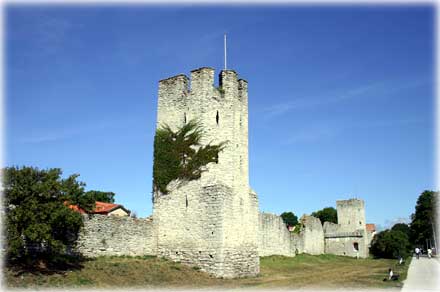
[410,191,438,245]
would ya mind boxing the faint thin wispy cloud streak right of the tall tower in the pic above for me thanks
[263,79,427,119]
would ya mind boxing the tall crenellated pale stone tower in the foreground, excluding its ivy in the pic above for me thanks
[153,67,259,278]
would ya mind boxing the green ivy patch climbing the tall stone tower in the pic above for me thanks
[153,120,225,194]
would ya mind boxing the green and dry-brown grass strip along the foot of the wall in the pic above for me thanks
[4,254,409,288]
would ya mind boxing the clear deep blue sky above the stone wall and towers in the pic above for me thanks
[5,5,435,226]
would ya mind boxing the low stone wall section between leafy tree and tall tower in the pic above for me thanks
[76,215,156,257]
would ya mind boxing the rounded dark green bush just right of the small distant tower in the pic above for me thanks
[370,229,411,259]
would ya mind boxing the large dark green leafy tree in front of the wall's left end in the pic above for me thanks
[3,167,87,263]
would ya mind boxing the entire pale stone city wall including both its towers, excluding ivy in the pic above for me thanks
[74,67,368,278]
